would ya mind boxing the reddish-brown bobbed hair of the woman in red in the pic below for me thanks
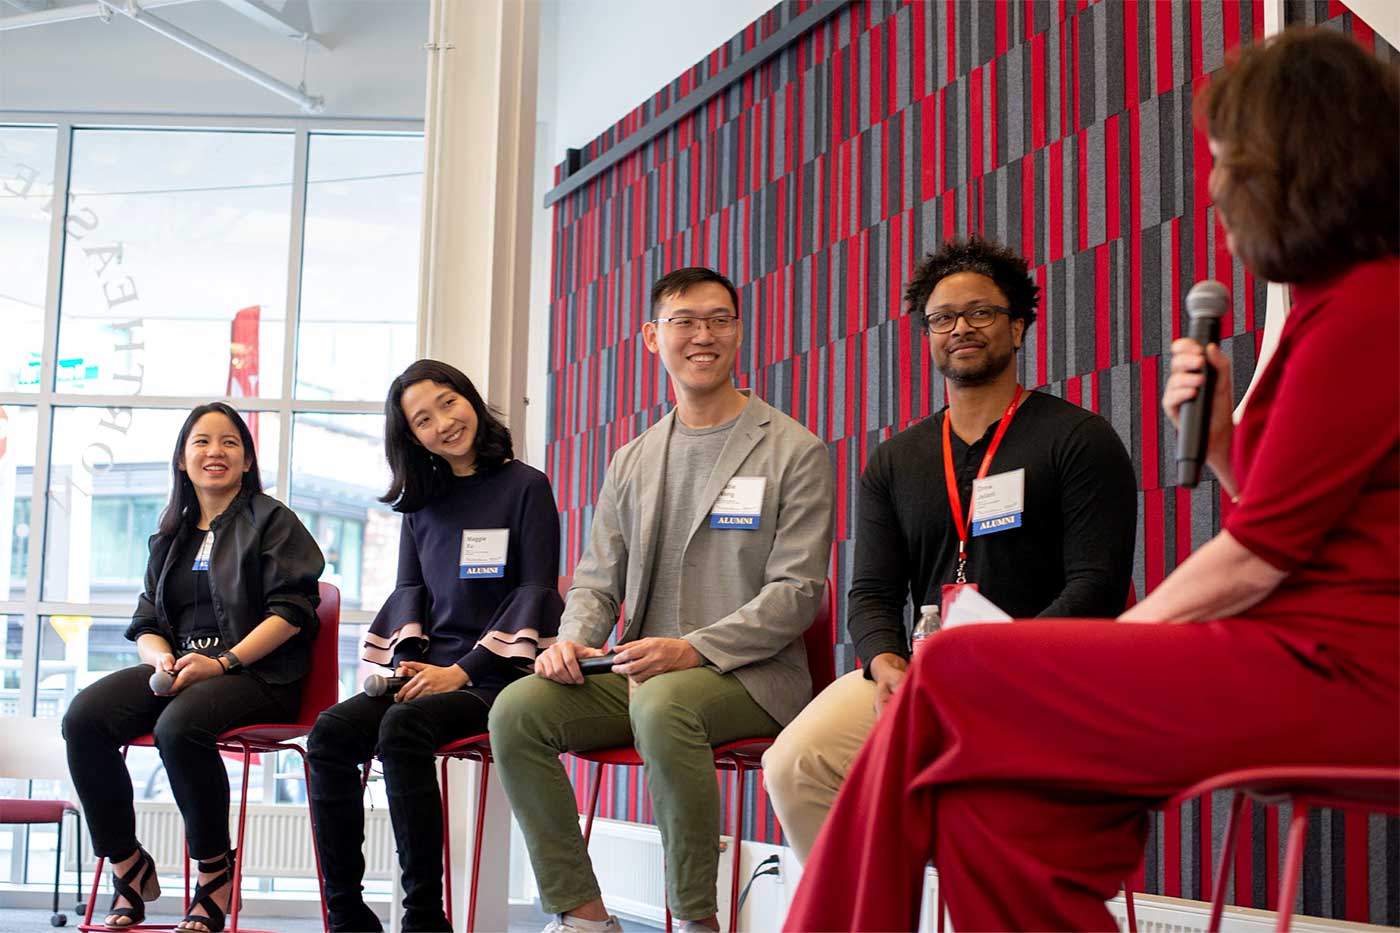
[1196,27,1400,282]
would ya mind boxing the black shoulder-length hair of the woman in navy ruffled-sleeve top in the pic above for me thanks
[379,360,515,511]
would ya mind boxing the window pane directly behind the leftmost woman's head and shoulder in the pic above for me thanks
[43,408,279,602]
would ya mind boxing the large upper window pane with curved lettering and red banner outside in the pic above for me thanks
[56,130,294,398]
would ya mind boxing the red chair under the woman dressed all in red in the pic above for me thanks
[1123,765,1400,933]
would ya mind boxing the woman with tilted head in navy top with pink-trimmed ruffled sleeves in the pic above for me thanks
[308,360,564,930]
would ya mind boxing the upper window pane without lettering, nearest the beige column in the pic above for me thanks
[297,134,423,399]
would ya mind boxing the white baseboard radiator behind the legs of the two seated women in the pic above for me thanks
[63,801,398,881]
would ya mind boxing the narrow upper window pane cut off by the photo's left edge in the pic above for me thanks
[0,126,57,392]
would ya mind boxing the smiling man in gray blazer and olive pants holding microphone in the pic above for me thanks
[490,268,834,932]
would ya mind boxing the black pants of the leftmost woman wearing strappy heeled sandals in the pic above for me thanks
[63,664,301,859]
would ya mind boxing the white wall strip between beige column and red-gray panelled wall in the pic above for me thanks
[525,0,777,468]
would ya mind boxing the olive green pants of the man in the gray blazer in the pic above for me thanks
[490,667,780,920]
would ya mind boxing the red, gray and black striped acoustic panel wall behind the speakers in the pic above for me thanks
[546,0,1400,923]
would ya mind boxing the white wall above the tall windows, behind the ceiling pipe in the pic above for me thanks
[0,0,428,120]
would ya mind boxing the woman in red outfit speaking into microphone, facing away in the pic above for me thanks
[787,29,1400,930]
